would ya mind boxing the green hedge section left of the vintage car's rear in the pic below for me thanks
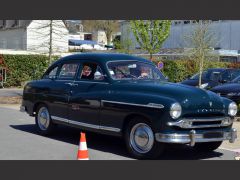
[3,55,58,87]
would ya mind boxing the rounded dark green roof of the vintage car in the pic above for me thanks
[54,53,152,64]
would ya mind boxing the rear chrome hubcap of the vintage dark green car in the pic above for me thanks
[37,107,50,131]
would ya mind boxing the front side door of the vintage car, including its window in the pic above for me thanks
[69,61,109,130]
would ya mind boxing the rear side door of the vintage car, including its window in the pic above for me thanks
[48,62,79,121]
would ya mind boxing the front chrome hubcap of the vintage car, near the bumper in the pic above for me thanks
[130,123,154,153]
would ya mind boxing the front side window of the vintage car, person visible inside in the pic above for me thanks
[79,63,104,81]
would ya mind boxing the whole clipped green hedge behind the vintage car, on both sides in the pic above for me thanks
[0,55,240,87]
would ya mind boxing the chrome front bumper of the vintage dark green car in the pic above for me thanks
[155,128,237,146]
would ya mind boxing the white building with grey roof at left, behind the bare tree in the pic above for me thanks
[0,20,68,53]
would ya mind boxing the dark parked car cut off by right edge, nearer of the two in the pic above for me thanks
[211,76,240,104]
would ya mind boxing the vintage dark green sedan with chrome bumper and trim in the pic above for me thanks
[21,53,237,159]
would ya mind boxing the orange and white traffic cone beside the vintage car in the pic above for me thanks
[77,132,89,160]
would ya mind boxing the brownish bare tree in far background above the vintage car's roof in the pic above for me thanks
[82,20,119,45]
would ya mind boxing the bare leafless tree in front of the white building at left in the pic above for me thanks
[28,20,68,63]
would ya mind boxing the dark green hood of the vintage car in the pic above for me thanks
[113,81,224,109]
